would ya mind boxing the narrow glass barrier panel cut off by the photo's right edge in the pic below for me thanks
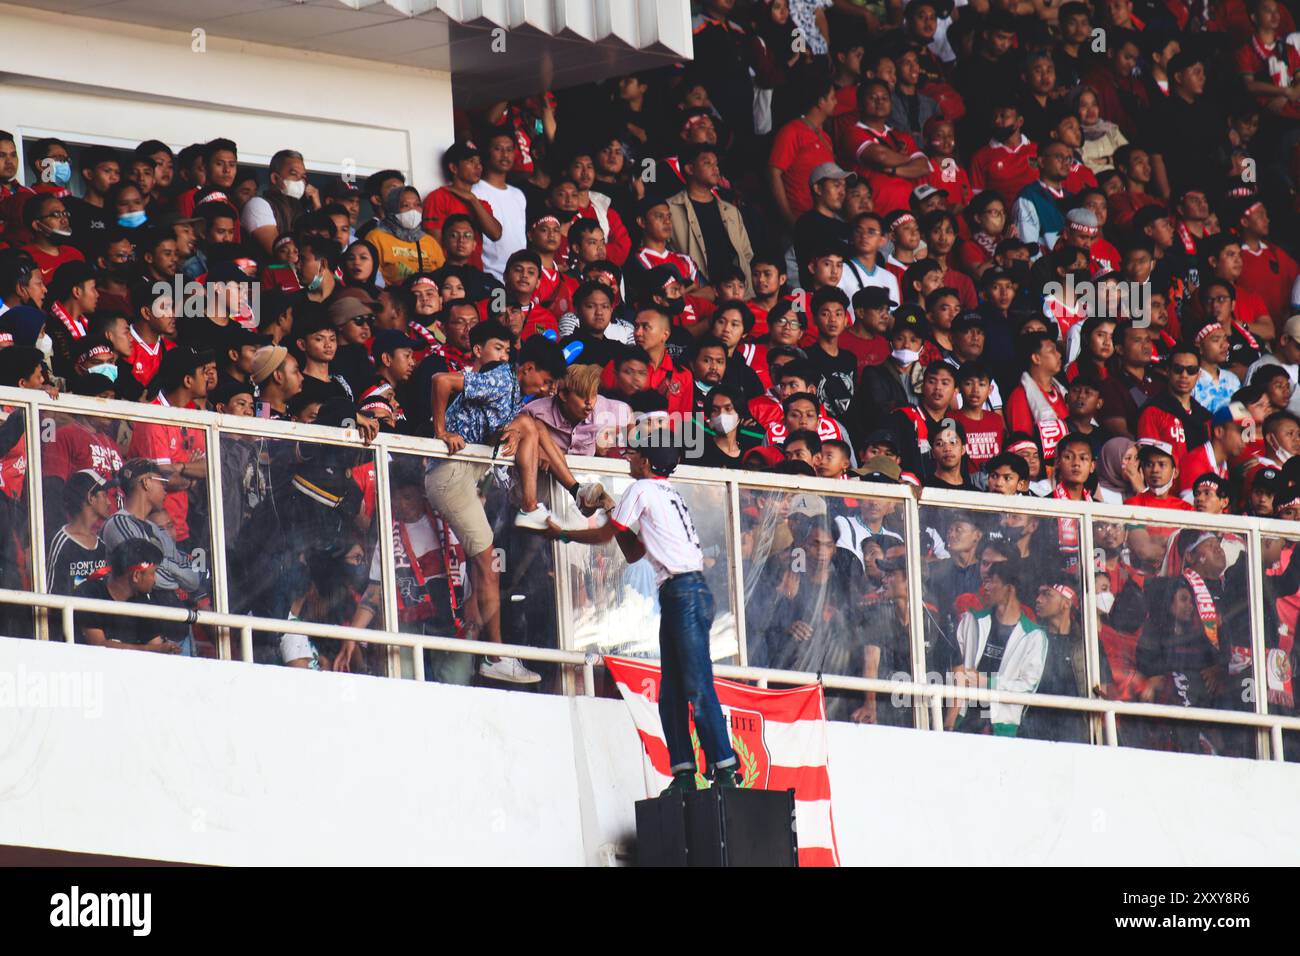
[1260,535,1300,761]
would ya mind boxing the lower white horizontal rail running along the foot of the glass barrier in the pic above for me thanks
[10,589,1300,731]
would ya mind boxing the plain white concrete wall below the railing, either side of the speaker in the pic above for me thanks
[0,640,1300,865]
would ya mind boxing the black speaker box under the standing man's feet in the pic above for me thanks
[637,787,800,866]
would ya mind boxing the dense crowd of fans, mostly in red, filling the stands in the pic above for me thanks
[0,0,1300,752]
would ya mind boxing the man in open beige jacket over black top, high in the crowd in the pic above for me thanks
[668,143,754,298]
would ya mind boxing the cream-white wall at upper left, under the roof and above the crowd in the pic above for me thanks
[0,4,452,193]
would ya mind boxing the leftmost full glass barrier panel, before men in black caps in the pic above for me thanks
[39,411,217,657]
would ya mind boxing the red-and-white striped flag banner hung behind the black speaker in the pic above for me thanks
[605,657,840,866]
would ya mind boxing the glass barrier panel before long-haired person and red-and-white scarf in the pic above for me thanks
[1092,520,1256,757]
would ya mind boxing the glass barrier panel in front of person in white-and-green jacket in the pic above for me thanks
[920,498,1092,744]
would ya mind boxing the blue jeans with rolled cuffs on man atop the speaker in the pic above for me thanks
[659,571,736,774]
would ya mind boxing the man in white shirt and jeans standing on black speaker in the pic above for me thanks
[549,416,737,792]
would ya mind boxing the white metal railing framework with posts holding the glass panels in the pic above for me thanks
[0,389,1300,761]
